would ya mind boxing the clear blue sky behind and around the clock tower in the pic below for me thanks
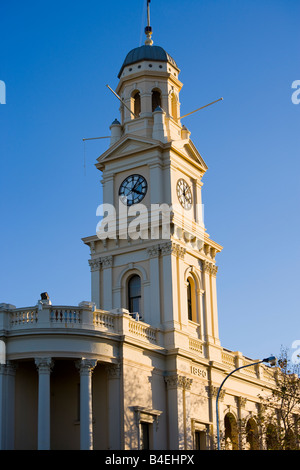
[0,0,300,358]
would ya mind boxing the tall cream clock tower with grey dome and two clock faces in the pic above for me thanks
[84,14,222,359]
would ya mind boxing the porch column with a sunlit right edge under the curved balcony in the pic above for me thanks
[76,359,97,450]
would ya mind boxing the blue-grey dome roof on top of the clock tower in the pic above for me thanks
[118,45,179,78]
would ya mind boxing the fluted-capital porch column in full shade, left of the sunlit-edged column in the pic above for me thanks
[35,357,53,450]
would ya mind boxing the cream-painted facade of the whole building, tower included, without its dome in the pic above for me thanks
[0,30,273,450]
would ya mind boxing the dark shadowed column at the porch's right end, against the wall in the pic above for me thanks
[106,364,121,450]
